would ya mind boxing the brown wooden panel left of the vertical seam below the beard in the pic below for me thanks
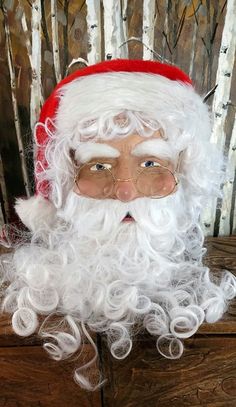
[0,345,101,407]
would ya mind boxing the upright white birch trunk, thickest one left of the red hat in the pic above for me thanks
[30,0,42,137]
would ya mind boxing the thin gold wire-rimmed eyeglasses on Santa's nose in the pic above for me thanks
[74,151,183,199]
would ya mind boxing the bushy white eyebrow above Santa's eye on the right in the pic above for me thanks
[131,139,175,159]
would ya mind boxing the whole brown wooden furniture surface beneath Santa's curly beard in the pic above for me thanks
[0,236,236,407]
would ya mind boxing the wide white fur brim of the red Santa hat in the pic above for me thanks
[56,72,210,150]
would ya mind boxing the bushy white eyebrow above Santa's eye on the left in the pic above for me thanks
[75,142,120,164]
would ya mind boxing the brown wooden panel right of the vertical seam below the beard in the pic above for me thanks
[102,336,236,407]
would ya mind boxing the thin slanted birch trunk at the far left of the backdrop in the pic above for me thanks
[3,8,30,197]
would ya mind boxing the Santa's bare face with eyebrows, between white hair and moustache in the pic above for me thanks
[74,131,177,206]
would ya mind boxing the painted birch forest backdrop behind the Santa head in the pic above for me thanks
[0,0,236,235]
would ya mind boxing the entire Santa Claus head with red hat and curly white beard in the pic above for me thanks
[2,60,236,388]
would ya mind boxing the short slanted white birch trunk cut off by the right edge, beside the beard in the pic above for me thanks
[219,115,236,235]
